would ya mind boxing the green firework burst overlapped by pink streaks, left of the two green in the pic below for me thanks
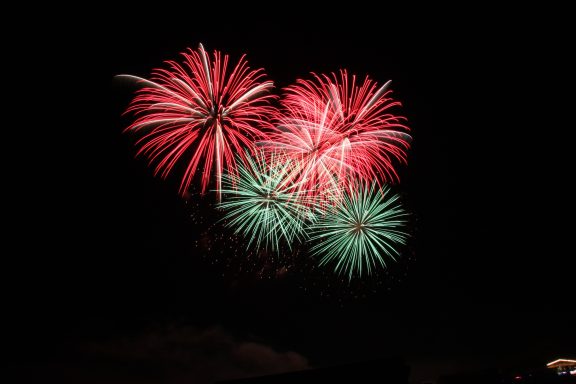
[218,152,314,253]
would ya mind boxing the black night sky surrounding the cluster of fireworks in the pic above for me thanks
[11,4,576,383]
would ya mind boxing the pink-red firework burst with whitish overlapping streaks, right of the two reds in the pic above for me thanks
[264,70,411,202]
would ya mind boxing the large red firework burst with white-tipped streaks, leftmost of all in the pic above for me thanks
[120,44,275,198]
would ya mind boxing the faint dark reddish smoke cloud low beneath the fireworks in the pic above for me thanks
[82,326,309,384]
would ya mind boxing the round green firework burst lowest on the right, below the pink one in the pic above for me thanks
[311,184,408,279]
